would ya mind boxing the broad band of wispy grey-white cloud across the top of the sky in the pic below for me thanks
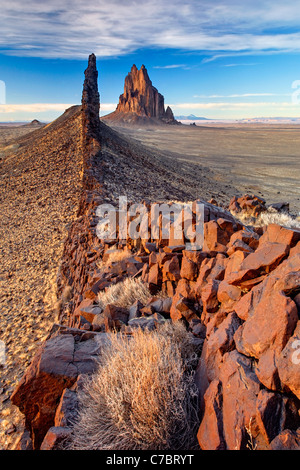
[0,0,300,58]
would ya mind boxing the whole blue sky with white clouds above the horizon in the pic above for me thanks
[0,0,300,122]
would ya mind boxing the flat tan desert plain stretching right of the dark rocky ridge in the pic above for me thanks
[108,123,300,215]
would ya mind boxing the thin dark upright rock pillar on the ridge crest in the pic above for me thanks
[81,54,100,138]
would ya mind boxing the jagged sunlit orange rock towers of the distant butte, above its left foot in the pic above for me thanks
[116,64,175,122]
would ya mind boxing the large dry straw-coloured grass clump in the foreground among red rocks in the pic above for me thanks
[70,322,199,450]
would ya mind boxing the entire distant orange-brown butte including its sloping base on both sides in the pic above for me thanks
[103,65,179,124]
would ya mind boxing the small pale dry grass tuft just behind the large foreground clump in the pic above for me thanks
[98,278,155,309]
